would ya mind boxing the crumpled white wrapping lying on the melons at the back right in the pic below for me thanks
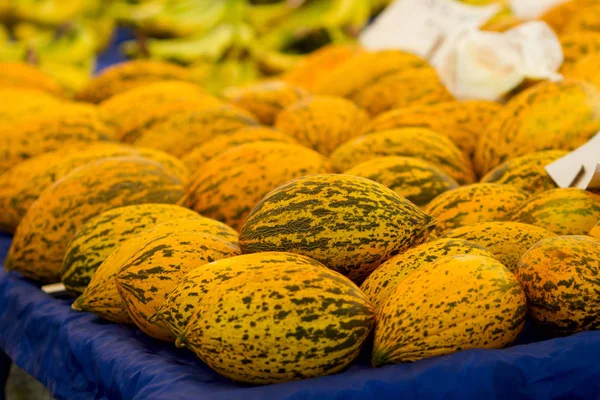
[432,21,563,100]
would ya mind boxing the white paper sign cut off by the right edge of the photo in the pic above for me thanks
[546,133,600,189]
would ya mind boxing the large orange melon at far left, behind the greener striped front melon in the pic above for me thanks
[5,157,183,282]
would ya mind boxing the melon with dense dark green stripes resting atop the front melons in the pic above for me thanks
[240,174,435,282]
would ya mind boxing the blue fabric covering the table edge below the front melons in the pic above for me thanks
[0,236,600,400]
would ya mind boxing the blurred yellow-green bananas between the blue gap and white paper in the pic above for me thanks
[118,0,384,91]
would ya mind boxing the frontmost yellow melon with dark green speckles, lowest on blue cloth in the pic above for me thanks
[181,261,374,384]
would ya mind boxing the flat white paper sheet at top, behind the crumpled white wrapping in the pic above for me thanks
[360,0,500,59]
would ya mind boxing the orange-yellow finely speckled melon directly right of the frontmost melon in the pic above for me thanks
[372,254,527,367]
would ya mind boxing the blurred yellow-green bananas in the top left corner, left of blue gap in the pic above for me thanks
[0,0,115,92]
